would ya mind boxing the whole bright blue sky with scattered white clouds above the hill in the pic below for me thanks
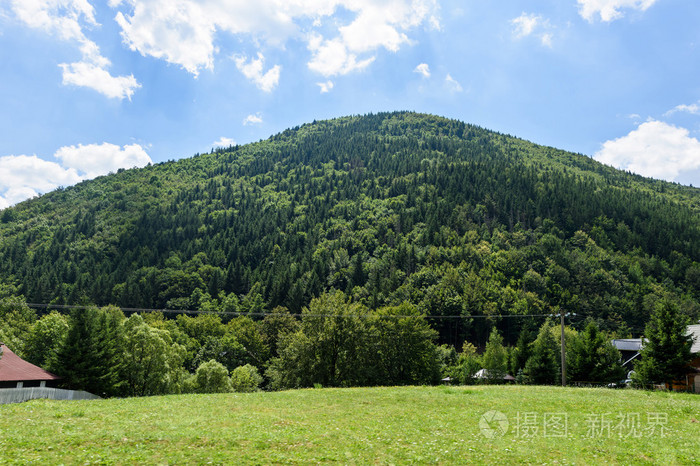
[0,0,700,209]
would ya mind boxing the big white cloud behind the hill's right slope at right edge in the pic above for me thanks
[594,120,700,181]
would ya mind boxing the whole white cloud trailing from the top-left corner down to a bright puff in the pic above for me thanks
[11,0,140,99]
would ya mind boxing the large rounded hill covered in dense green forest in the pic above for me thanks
[0,113,700,346]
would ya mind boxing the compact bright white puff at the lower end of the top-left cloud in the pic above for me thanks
[59,62,141,100]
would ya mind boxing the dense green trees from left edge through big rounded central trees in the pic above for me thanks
[0,292,441,396]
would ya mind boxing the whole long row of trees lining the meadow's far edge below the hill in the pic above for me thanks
[0,291,656,396]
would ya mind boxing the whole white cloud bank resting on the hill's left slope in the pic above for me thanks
[0,143,151,209]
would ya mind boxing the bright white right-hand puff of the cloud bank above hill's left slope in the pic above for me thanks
[54,142,151,179]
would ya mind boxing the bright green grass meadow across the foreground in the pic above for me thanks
[0,386,700,464]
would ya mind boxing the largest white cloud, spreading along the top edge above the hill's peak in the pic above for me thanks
[109,0,439,78]
